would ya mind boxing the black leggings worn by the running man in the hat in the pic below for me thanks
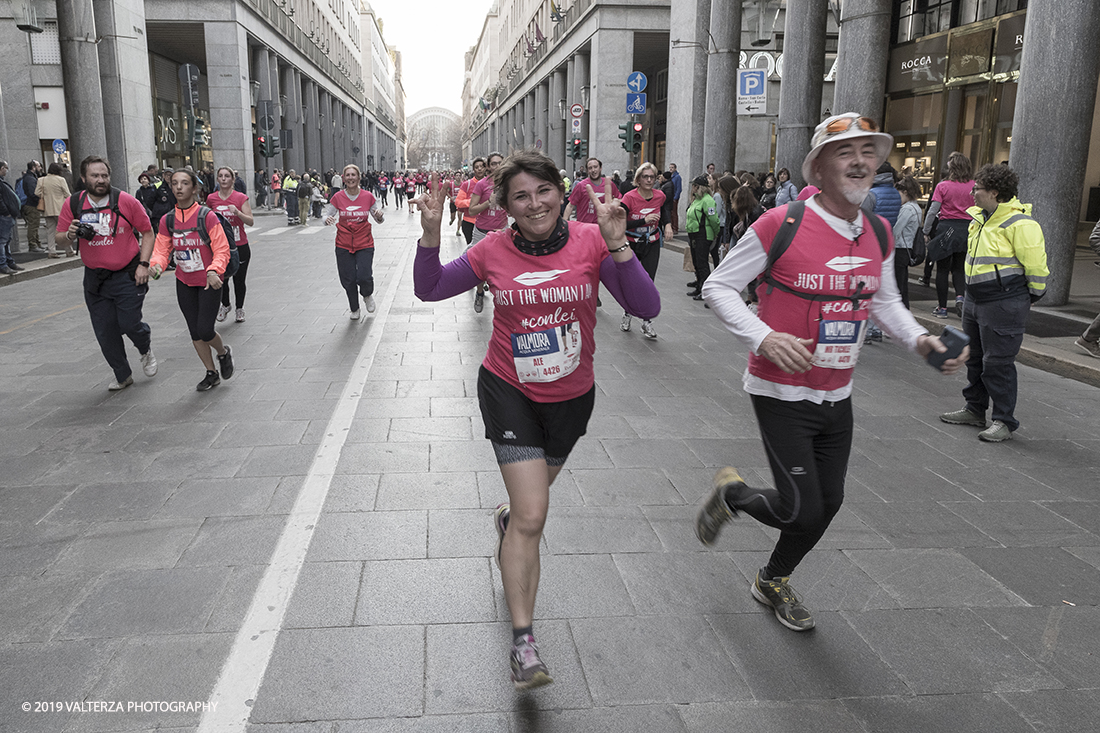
[737,395,853,578]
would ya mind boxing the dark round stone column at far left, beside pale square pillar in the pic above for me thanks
[56,0,107,173]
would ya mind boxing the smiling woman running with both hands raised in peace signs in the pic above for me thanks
[414,151,660,690]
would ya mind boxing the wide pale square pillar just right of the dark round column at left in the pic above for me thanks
[95,0,155,190]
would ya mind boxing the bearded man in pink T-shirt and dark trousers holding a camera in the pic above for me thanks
[54,155,156,392]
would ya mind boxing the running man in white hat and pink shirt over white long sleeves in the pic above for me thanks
[695,113,966,631]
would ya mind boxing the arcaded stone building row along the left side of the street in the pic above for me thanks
[0,0,403,189]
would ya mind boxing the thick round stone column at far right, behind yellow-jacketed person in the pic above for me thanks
[1009,0,1100,306]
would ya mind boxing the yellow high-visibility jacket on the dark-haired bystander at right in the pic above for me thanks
[966,197,1051,302]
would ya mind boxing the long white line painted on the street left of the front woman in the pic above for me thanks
[198,243,416,733]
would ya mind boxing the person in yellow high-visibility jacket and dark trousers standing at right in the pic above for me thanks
[939,165,1051,442]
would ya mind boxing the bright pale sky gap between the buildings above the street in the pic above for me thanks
[370,0,493,116]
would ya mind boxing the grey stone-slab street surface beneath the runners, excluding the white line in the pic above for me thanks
[0,206,1100,733]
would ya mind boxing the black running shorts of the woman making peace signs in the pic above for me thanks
[477,367,596,458]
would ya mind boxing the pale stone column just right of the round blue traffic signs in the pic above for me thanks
[664,0,708,203]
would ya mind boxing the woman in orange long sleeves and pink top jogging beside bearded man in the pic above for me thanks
[150,168,235,392]
